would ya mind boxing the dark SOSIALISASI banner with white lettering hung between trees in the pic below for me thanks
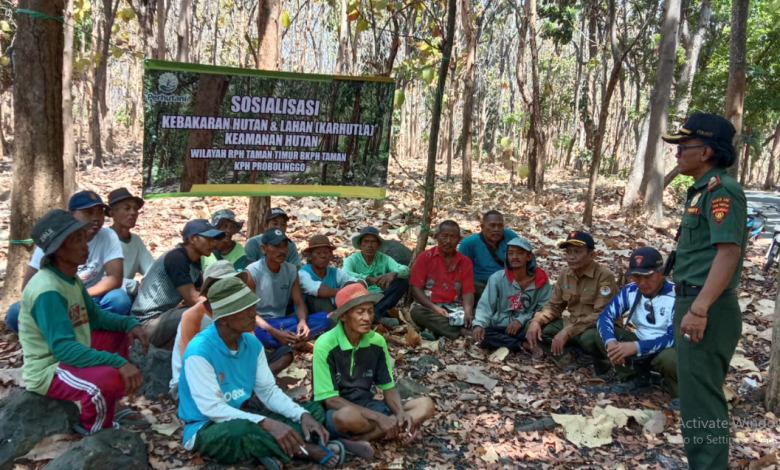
[143,60,395,199]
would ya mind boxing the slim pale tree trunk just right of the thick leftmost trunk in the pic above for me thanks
[62,0,79,195]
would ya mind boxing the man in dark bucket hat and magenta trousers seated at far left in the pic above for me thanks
[19,209,149,434]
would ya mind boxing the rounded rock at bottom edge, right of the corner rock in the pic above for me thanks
[43,429,149,470]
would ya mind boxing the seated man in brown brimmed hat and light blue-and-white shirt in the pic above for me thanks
[298,235,361,313]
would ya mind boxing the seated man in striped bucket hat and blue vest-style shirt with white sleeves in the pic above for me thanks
[179,277,346,469]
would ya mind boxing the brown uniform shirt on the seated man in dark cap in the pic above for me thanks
[534,261,618,337]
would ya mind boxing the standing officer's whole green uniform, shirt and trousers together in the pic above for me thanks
[674,168,747,470]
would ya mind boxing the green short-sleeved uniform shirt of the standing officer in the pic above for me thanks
[674,168,747,289]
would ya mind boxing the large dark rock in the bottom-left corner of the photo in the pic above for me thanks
[0,390,79,470]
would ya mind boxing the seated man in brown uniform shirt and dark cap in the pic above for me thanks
[526,232,617,375]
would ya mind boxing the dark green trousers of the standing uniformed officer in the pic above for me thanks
[674,294,742,470]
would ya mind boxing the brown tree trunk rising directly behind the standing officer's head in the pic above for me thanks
[725,0,750,178]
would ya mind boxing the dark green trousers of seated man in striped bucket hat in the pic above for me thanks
[193,403,325,464]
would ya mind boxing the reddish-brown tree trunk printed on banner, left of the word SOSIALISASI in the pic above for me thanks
[180,73,230,192]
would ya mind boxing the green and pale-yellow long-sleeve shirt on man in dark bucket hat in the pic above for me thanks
[19,266,138,395]
